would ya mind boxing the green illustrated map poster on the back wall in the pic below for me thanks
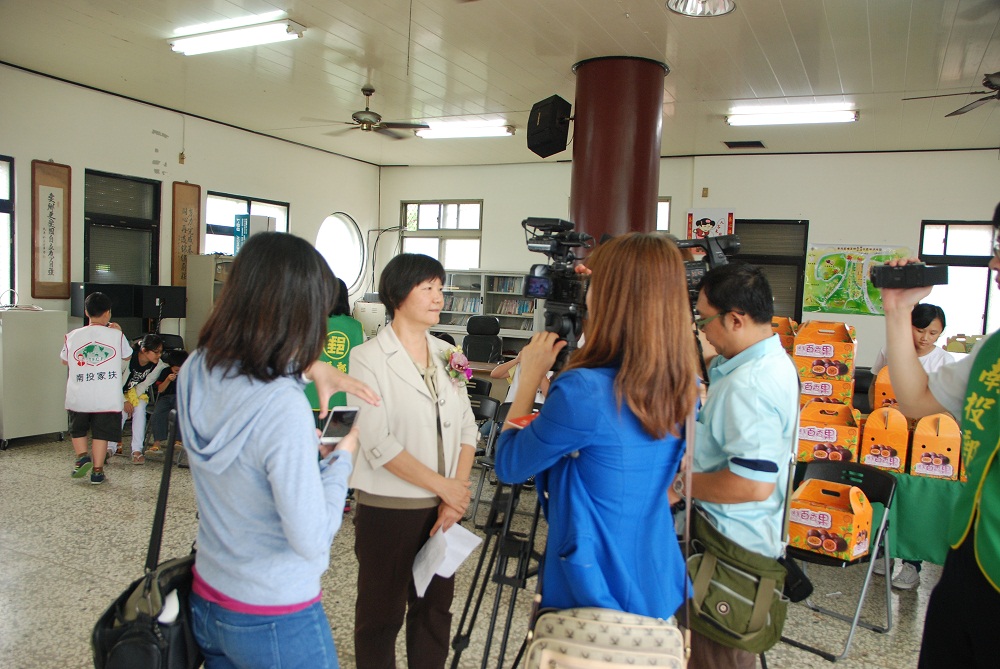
[802,245,910,316]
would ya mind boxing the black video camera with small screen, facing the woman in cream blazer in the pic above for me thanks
[521,218,594,371]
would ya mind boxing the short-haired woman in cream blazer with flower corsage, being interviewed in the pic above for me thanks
[350,253,476,669]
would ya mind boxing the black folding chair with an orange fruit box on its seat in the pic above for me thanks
[781,461,896,662]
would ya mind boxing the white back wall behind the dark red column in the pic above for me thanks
[376,150,1000,365]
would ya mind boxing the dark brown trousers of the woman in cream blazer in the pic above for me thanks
[354,505,455,669]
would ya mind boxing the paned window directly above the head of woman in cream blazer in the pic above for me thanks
[402,200,483,270]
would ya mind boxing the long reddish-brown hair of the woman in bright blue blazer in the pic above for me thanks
[566,233,698,439]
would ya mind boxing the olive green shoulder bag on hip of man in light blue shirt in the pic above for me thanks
[687,510,788,655]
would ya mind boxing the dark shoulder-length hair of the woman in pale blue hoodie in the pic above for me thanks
[198,232,338,381]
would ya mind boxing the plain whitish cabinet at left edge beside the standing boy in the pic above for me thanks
[0,309,68,448]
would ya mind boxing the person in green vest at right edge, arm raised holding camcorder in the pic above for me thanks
[882,205,1000,669]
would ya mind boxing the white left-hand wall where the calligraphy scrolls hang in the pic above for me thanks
[0,66,379,332]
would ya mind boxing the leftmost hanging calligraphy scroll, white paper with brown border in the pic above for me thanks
[31,160,71,299]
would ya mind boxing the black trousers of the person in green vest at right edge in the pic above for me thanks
[917,531,1000,669]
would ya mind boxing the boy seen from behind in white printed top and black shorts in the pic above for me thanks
[59,293,132,485]
